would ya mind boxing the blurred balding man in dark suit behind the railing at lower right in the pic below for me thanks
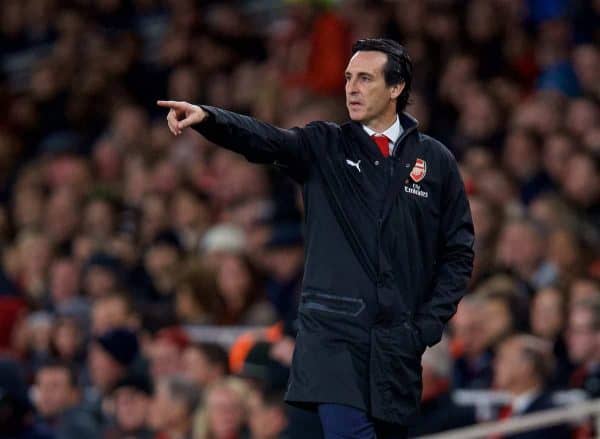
[494,334,571,439]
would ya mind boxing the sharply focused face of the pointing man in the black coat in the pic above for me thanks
[346,51,403,125]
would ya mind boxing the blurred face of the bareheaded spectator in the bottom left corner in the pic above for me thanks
[36,367,76,418]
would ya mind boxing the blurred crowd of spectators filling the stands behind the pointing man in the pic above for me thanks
[0,0,600,439]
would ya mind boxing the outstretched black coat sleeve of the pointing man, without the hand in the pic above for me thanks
[193,105,310,179]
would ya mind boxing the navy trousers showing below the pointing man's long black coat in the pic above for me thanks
[319,404,406,439]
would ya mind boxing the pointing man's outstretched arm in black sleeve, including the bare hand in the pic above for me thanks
[157,101,310,179]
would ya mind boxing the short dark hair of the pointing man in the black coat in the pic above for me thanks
[352,38,412,113]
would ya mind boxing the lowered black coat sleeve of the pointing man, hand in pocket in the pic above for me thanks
[415,151,474,346]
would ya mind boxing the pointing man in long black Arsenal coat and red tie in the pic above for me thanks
[158,39,473,438]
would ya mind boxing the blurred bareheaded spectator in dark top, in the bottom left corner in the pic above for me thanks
[34,361,99,439]
